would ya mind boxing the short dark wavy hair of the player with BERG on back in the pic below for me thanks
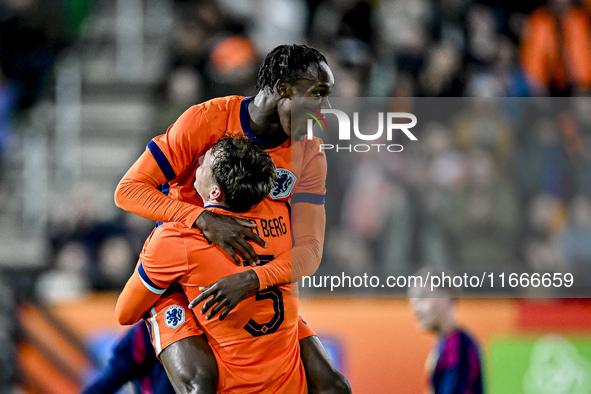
[211,136,277,212]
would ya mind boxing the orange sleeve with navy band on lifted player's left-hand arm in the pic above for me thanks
[115,96,243,226]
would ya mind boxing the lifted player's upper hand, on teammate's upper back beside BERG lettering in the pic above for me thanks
[195,211,267,266]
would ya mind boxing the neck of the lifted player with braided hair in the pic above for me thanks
[248,91,286,141]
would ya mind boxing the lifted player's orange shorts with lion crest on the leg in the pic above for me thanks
[144,286,316,355]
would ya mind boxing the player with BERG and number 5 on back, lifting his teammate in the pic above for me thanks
[116,137,307,394]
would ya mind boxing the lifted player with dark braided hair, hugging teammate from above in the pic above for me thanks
[115,45,350,393]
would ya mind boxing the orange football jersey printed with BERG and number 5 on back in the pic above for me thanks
[118,204,307,393]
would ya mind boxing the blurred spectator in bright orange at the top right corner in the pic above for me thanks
[521,0,591,96]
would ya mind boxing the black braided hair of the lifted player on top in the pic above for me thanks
[256,44,326,90]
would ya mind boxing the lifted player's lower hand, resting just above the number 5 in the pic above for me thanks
[189,270,260,320]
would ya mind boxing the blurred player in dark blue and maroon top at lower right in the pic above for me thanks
[408,268,483,394]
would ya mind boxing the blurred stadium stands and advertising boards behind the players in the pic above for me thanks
[0,0,591,394]
